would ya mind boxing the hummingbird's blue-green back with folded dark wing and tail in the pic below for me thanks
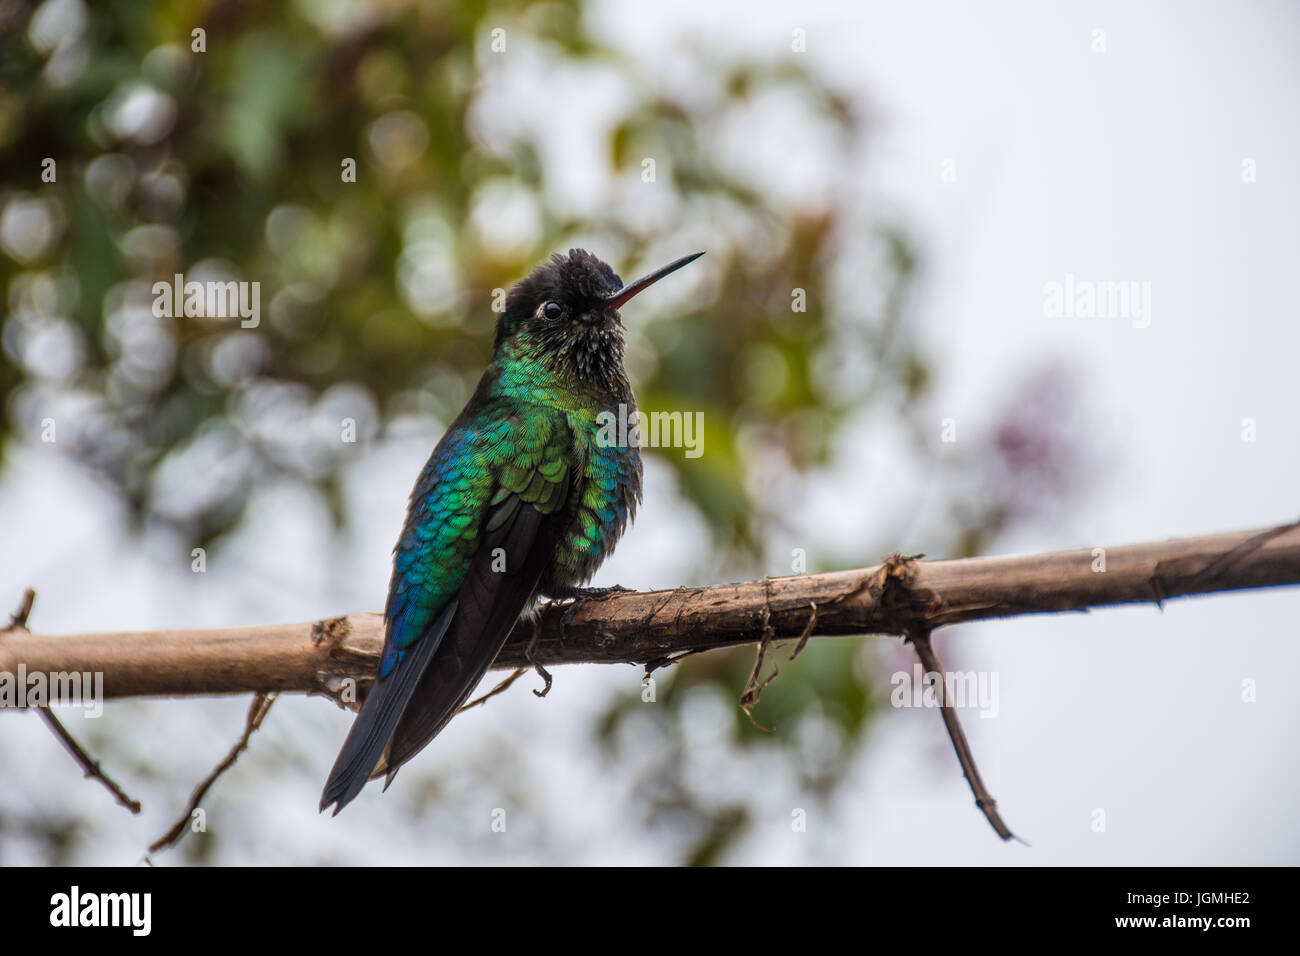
[321,410,573,813]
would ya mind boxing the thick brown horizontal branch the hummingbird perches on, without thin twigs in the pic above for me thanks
[0,524,1300,701]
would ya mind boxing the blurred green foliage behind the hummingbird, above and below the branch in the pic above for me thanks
[0,0,1081,862]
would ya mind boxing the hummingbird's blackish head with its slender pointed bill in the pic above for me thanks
[495,248,703,392]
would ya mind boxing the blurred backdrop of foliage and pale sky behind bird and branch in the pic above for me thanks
[0,0,1300,865]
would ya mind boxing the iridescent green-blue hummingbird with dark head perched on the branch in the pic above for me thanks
[321,248,703,814]
